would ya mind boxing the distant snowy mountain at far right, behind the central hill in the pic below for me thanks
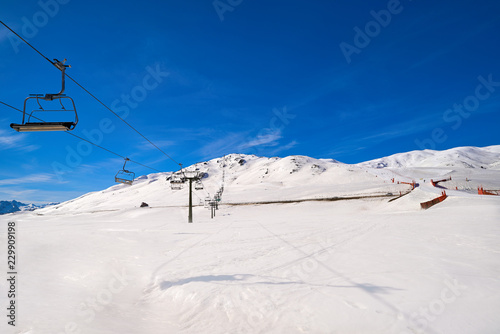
[359,145,500,170]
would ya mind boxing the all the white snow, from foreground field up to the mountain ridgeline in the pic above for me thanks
[0,146,500,334]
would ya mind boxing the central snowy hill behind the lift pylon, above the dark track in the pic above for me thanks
[40,154,408,213]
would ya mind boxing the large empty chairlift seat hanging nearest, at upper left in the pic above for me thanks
[10,59,78,132]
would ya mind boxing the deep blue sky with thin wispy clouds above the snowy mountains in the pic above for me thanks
[0,0,500,202]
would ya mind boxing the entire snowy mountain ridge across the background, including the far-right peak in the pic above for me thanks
[31,146,500,217]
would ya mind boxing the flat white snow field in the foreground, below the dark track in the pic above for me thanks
[3,195,500,333]
